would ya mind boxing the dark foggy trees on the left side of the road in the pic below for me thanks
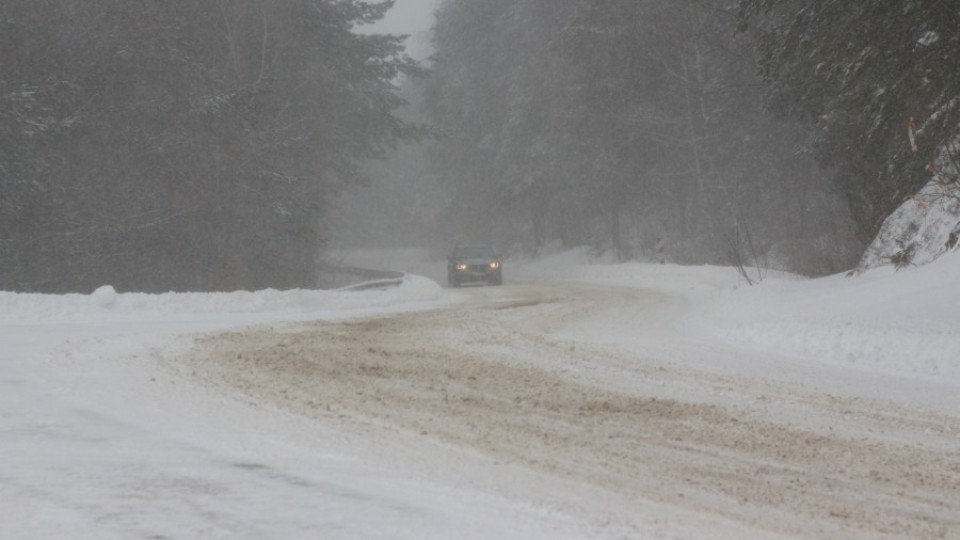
[0,0,418,292]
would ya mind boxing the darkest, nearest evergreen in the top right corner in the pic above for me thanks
[740,0,960,246]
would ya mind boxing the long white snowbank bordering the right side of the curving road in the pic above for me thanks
[496,245,960,382]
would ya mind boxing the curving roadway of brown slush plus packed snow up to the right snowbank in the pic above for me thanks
[176,282,960,539]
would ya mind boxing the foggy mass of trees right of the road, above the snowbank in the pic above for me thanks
[424,0,958,274]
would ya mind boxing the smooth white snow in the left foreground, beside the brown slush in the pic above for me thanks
[0,302,592,539]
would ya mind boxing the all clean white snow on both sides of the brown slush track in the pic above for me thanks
[0,251,960,539]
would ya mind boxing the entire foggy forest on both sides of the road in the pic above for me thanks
[0,0,960,292]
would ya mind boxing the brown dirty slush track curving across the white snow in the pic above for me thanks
[176,285,960,539]
